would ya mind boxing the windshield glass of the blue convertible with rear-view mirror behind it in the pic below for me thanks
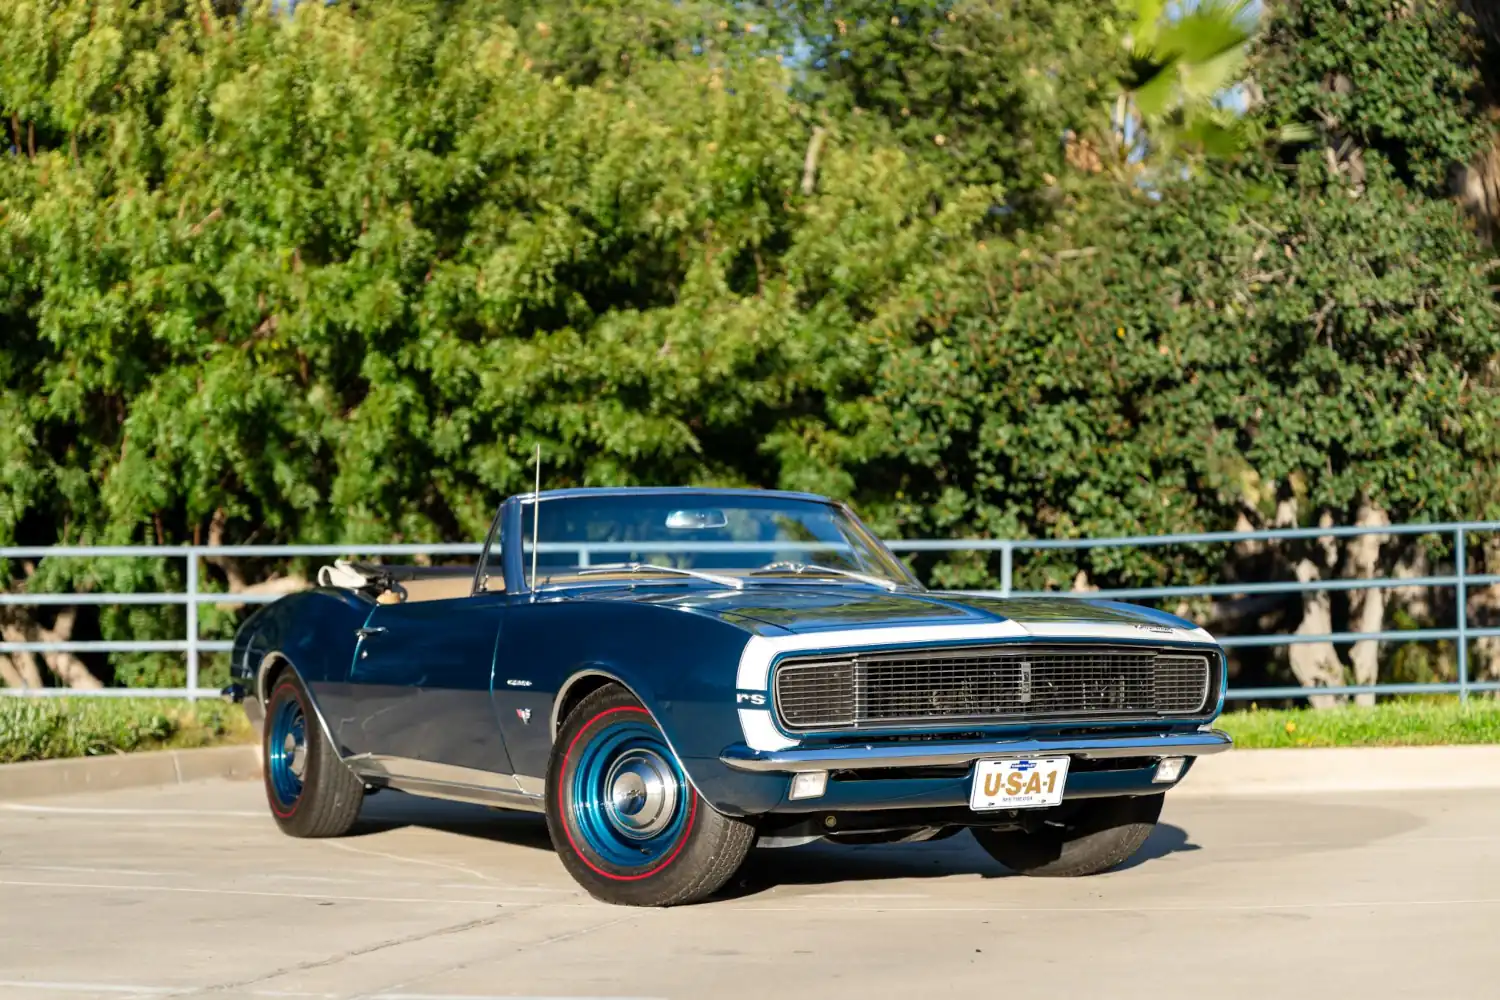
[522,493,917,589]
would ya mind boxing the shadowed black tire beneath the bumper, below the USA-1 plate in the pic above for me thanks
[974,795,1166,879]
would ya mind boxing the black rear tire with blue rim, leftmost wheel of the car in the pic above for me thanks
[261,670,365,837]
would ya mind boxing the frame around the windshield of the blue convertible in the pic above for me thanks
[498,487,927,598]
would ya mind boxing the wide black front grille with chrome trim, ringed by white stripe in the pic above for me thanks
[774,645,1212,732]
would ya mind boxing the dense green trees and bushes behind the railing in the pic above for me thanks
[0,0,1500,692]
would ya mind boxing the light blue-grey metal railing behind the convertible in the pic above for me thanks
[0,522,1500,700]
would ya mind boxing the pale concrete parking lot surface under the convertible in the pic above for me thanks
[0,781,1500,1000]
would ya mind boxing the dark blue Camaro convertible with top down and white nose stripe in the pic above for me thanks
[233,489,1230,906]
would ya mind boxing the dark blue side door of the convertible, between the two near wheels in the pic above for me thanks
[339,594,512,781]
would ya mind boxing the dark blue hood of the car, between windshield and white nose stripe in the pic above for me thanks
[635,585,1197,634]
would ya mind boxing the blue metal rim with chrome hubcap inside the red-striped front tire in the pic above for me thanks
[569,720,692,868]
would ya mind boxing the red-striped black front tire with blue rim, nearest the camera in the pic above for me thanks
[546,685,755,906]
